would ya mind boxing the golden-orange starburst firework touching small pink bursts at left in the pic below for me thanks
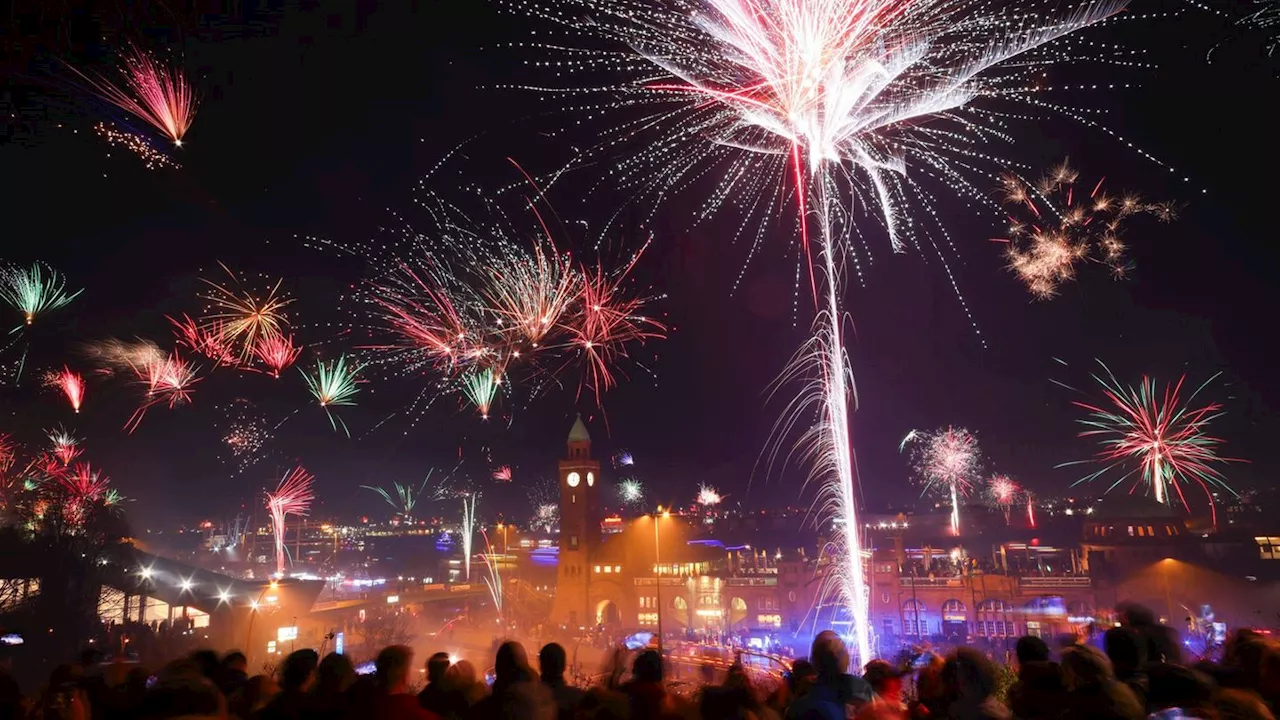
[201,263,293,364]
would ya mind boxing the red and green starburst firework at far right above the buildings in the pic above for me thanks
[1059,361,1243,525]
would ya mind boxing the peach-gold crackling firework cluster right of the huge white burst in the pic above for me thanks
[997,161,1174,300]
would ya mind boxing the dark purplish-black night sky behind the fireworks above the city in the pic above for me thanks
[0,0,1280,528]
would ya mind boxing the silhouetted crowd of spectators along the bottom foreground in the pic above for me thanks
[0,599,1280,720]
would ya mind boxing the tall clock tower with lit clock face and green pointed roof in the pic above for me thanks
[550,415,600,629]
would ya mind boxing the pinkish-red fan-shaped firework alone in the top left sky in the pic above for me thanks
[68,45,196,147]
